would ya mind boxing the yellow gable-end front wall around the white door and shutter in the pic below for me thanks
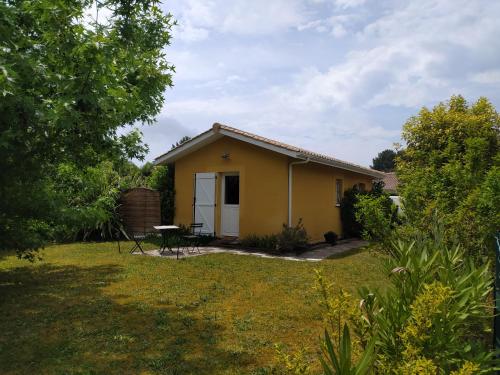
[174,137,288,237]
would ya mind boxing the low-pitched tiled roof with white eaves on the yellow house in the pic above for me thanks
[154,123,383,178]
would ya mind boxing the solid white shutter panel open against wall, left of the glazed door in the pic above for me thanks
[194,173,216,235]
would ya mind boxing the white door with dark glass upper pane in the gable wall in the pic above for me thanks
[221,173,240,237]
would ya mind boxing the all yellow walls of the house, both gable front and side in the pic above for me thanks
[174,137,371,241]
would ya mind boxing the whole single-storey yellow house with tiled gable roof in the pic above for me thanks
[155,123,382,241]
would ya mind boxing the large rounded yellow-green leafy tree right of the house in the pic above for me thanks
[397,96,500,257]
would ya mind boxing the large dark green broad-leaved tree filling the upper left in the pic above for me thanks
[0,0,175,256]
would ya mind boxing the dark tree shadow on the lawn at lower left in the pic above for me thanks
[0,265,253,374]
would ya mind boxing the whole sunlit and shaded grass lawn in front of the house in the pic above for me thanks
[0,243,385,374]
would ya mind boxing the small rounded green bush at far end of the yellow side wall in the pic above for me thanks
[354,194,398,245]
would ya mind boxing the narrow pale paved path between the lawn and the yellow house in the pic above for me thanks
[134,239,368,262]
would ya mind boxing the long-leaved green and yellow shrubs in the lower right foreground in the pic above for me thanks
[325,227,494,374]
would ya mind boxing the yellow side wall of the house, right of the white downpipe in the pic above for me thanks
[292,163,371,242]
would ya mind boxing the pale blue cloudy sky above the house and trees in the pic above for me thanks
[140,0,500,166]
